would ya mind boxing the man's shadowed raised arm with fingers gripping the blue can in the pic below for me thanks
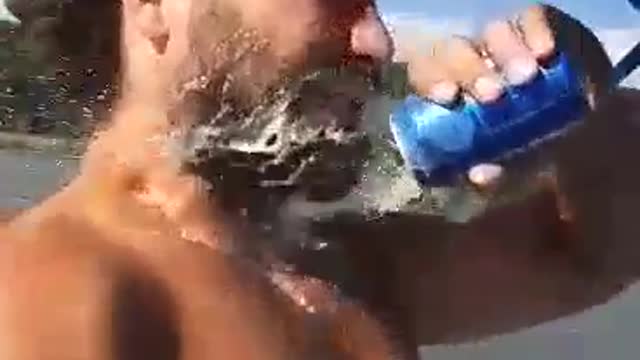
[292,4,640,347]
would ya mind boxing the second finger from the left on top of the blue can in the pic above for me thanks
[434,37,504,102]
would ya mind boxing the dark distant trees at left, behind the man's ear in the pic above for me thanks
[0,0,118,136]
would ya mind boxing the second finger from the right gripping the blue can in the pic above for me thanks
[483,21,538,85]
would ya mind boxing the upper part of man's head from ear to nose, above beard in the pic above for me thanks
[117,0,392,101]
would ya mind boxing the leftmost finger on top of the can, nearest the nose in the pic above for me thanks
[408,52,460,104]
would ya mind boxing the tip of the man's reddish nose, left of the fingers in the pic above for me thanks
[351,7,393,62]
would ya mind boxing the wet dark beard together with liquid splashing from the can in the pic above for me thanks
[164,64,476,254]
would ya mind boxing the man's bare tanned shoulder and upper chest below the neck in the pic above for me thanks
[0,194,394,359]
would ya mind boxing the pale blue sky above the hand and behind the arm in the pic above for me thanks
[377,0,640,87]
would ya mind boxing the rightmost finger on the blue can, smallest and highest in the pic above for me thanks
[518,5,556,60]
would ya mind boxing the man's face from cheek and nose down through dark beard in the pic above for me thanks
[123,0,392,208]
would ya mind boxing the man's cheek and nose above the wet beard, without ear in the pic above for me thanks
[182,0,391,90]
